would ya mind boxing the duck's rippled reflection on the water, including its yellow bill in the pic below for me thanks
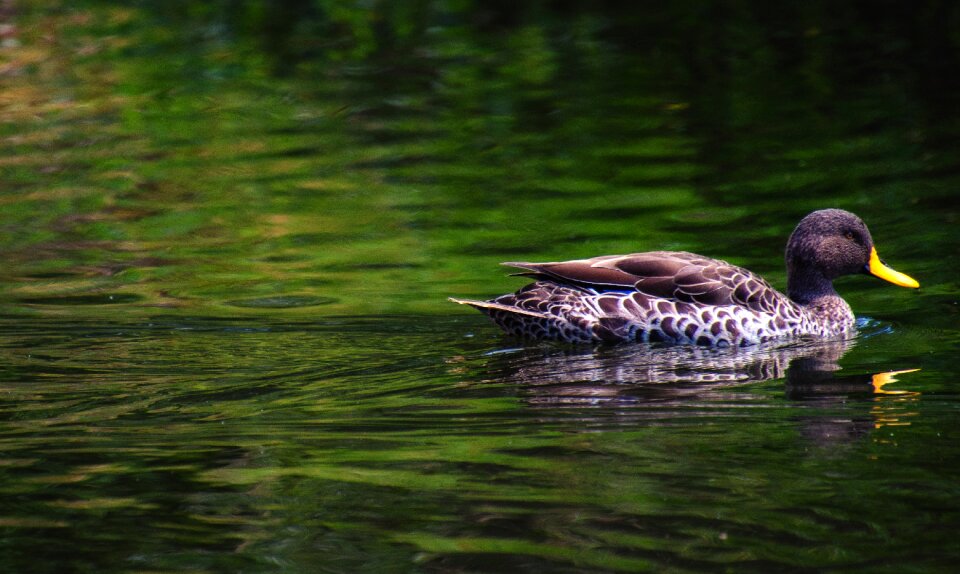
[476,339,918,442]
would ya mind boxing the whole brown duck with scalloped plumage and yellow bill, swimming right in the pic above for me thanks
[450,209,920,347]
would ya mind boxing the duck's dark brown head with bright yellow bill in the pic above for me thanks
[786,209,920,301]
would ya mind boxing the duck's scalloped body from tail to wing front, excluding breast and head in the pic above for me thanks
[460,251,832,346]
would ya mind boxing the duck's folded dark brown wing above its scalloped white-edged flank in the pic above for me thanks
[504,251,786,312]
